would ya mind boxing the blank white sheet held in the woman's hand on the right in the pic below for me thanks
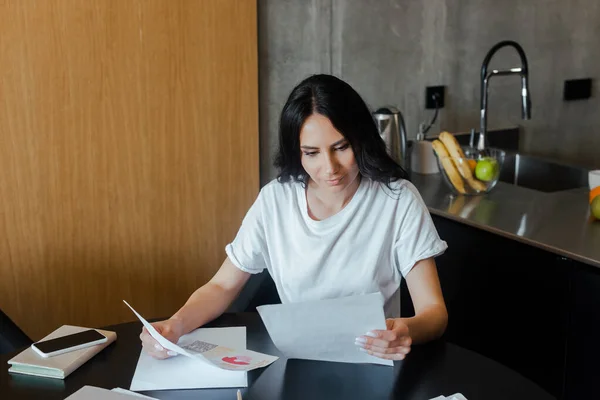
[256,293,394,365]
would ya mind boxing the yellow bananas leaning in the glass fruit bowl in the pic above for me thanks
[432,132,486,194]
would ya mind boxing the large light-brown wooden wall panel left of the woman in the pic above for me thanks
[0,0,259,339]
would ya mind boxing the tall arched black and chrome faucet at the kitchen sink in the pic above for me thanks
[477,40,531,150]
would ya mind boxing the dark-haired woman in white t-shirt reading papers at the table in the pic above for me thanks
[140,75,448,360]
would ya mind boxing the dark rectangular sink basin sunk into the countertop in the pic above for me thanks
[499,152,588,192]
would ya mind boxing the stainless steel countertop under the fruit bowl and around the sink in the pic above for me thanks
[410,173,600,267]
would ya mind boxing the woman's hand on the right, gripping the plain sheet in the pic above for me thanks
[355,318,412,360]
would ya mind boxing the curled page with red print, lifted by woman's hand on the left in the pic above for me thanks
[123,300,279,371]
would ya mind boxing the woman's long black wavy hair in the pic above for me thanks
[274,74,408,187]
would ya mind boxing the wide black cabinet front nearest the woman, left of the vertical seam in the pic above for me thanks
[426,216,569,398]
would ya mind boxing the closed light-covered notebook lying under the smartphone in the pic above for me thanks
[8,325,117,379]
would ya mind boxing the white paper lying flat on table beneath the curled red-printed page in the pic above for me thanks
[129,326,248,391]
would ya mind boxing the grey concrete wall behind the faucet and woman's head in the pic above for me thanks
[258,0,600,184]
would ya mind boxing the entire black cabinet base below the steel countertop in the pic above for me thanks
[422,216,600,400]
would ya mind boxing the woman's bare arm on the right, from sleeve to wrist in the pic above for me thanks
[400,258,448,344]
